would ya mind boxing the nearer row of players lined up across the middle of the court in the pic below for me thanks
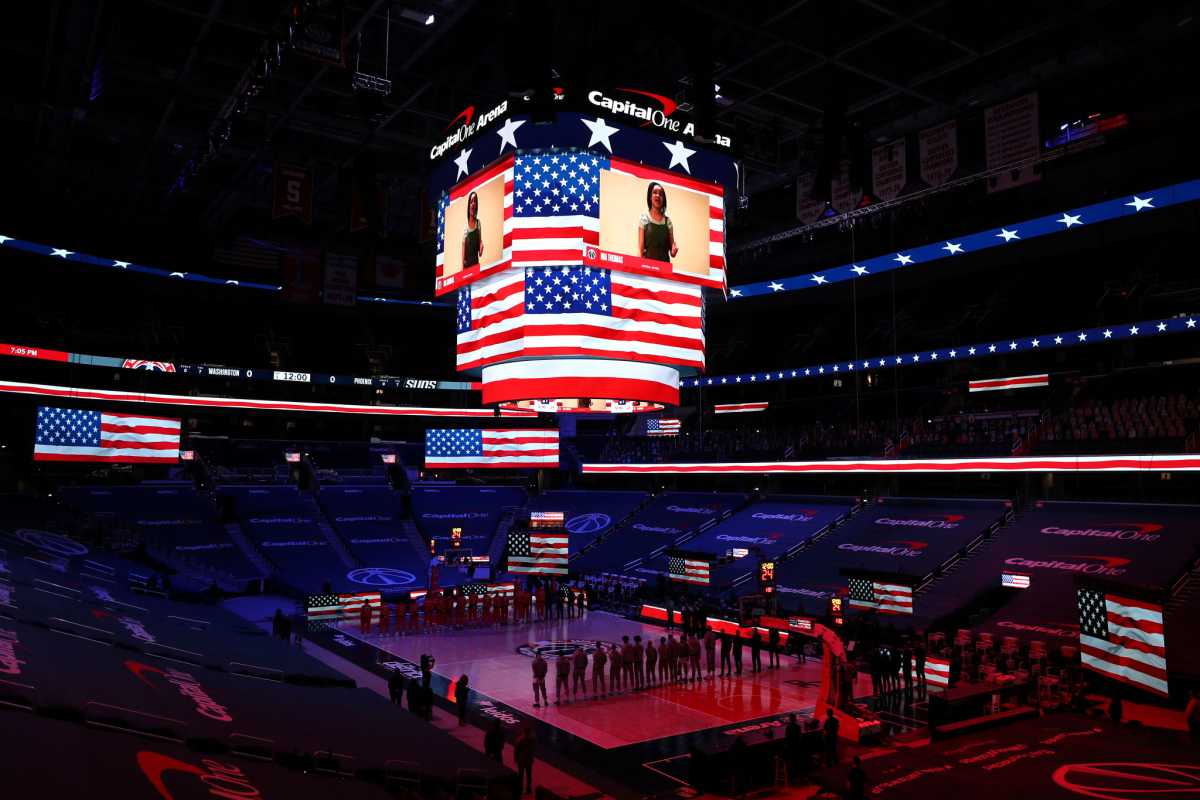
[533,627,720,708]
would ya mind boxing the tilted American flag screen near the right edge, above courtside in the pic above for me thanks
[1078,587,1168,697]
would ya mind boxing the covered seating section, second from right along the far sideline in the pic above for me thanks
[768,498,1006,602]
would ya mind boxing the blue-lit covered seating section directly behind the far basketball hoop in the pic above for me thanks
[412,486,526,555]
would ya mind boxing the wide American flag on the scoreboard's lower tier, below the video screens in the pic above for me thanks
[457,264,704,371]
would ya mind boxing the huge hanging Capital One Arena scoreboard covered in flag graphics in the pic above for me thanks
[431,90,739,413]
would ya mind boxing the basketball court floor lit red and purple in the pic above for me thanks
[337,612,821,748]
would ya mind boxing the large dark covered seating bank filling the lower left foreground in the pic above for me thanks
[0,525,512,798]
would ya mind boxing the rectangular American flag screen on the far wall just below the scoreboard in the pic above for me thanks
[425,428,558,469]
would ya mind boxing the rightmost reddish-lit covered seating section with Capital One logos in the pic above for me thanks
[913,503,1200,644]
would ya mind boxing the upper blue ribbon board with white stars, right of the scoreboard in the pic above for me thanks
[730,180,1200,300]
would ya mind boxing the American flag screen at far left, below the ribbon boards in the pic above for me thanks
[34,405,179,464]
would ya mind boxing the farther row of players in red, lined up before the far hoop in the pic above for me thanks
[359,588,587,634]
